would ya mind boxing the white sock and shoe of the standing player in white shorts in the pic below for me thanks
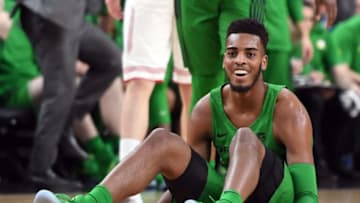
[119,138,143,203]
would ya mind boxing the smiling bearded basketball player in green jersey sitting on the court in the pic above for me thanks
[34,20,318,203]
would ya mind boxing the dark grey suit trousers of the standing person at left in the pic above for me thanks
[21,7,121,173]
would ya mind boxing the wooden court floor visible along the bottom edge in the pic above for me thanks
[0,189,360,203]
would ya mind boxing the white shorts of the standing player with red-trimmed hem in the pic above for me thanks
[123,0,191,84]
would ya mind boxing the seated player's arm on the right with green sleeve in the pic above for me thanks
[274,89,318,203]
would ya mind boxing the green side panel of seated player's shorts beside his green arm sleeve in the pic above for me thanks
[269,163,294,203]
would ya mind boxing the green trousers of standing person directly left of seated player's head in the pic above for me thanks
[180,0,250,109]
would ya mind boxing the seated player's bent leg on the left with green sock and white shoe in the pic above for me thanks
[34,129,194,203]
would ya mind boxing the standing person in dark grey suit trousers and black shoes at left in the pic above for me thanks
[18,0,121,189]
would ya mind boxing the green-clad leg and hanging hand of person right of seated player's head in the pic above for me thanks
[264,0,313,89]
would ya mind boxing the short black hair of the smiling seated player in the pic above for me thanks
[226,19,269,50]
